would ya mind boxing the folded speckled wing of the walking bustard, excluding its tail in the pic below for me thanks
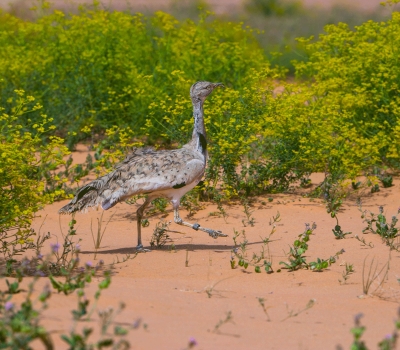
[99,148,205,209]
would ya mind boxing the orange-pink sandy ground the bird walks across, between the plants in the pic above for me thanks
[0,146,400,350]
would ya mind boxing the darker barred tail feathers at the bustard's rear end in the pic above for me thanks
[58,178,104,214]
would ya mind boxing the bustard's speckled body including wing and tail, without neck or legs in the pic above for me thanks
[59,146,205,213]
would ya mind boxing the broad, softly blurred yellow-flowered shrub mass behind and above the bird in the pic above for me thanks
[0,8,267,146]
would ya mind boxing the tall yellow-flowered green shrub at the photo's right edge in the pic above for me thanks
[296,1,400,170]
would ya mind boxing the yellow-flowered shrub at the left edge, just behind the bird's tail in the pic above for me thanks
[0,90,68,260]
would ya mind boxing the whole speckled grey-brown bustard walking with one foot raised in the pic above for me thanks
[59,81,227,251]
